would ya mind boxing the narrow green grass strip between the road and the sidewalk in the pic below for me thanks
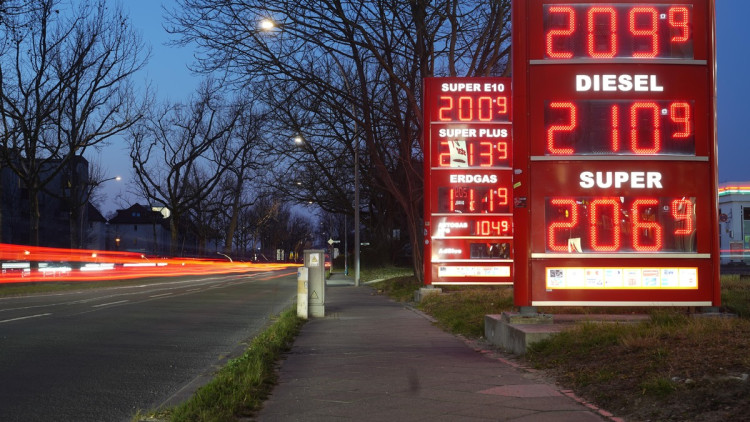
[134,306,303,422]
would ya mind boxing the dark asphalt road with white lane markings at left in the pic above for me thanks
[0,268,296,422]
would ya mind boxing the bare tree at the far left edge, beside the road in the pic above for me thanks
[0,0,148,245]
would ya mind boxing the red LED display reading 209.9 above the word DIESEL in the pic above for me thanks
[543,3,693,60]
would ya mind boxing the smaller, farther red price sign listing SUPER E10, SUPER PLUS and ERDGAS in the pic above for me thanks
[423,78,513,284]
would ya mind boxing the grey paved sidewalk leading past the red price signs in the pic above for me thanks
[257,274,613,422]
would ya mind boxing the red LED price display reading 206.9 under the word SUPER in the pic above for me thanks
[545,196,696,253]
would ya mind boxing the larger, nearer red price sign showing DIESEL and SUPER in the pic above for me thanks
[511,0,720,306]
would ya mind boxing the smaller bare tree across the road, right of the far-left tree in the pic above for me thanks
[130,81,246,255]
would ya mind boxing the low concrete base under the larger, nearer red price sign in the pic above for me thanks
[484,312,650,355]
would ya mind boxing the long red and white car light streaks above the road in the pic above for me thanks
[0,244,300,285]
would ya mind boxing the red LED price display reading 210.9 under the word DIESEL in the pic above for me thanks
[544,100,695,155]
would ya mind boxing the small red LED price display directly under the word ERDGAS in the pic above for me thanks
[437,186,510,214]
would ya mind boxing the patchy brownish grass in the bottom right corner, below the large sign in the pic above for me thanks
[524,310,750,420]
